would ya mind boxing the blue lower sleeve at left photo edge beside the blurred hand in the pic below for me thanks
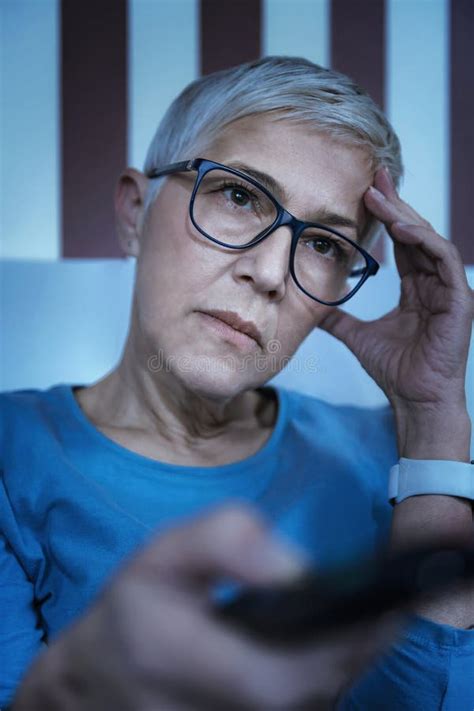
[0,533,45,709]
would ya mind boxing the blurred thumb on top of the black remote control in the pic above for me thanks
[130,505,308,590]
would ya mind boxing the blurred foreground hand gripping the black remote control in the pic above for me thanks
[13,506,398,711]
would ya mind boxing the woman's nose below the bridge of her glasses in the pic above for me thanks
[233,226,291,301]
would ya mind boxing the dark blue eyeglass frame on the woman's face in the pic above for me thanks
[147,158,380,306]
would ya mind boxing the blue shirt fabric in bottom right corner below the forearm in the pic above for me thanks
[337,615,474,711]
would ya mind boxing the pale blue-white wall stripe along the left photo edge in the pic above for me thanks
[0,0,60,259]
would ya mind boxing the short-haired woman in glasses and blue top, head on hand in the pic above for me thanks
[1,57,474,709]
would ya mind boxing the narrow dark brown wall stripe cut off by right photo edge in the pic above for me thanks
[450,0,474,264]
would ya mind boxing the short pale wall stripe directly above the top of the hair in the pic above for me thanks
[262,0,330,67]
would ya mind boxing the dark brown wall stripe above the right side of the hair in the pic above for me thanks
[331,0,385,261]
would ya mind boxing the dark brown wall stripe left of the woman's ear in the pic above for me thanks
[61,0,127,257]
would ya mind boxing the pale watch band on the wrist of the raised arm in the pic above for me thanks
[388,457,474,506]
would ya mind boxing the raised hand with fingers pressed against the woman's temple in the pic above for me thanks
[320,169,474,456]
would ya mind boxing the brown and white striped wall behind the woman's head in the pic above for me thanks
[0,0,474,264]
